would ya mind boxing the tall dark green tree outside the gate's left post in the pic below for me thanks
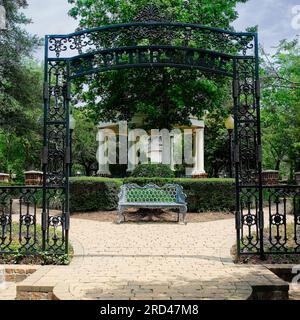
[0,0,43,178]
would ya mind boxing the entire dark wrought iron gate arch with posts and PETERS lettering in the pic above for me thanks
[5,21,290,256]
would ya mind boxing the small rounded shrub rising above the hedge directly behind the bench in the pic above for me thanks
[131,164,175,178]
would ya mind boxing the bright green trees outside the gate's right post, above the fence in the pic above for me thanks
[261,39,300,177]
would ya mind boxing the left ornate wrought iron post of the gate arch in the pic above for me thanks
[42,42,70,254]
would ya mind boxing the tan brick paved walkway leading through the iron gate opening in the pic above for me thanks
[13,219,282,300]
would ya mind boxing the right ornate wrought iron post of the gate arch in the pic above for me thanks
[233,51,264,258]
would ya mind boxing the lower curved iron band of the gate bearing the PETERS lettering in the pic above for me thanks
[70,46,233,78]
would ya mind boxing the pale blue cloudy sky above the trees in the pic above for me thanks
[24,0,300,61]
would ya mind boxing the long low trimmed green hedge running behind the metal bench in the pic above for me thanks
[70,177,235,212]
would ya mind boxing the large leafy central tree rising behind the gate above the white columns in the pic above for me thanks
[69,0,246,128]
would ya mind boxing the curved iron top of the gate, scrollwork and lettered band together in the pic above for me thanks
[45,22,257,78]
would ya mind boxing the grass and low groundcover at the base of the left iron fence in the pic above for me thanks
[0,222,73,265]
